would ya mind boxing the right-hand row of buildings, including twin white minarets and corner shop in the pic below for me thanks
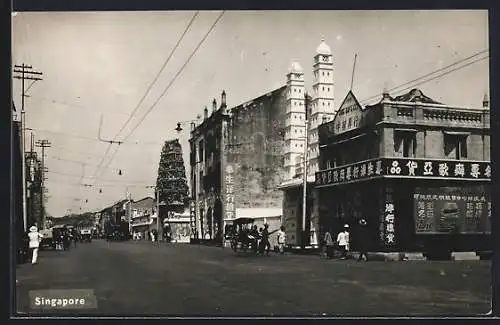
[186,41,491,256]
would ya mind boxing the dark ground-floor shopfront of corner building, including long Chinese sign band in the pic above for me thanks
[315,158,491,253]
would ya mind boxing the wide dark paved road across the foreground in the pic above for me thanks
[17,240,491,316]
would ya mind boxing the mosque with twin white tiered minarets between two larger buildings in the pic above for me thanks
[279,40,335,248]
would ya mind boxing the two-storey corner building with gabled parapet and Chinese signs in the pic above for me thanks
[315,89,491,256]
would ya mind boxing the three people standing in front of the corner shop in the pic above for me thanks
[323,219,368,261]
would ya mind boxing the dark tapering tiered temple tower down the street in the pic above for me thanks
[156,139,189,209]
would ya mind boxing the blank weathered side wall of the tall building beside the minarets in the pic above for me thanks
[228,87,285,208]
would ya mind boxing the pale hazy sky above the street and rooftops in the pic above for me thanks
[12,10,489,216]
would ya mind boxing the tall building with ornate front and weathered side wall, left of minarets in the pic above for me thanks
[190,83,288,241]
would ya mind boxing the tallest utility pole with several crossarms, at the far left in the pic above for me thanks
[13,63,42,232]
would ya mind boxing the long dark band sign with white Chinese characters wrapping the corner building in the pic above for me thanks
[316,158,491,186]
